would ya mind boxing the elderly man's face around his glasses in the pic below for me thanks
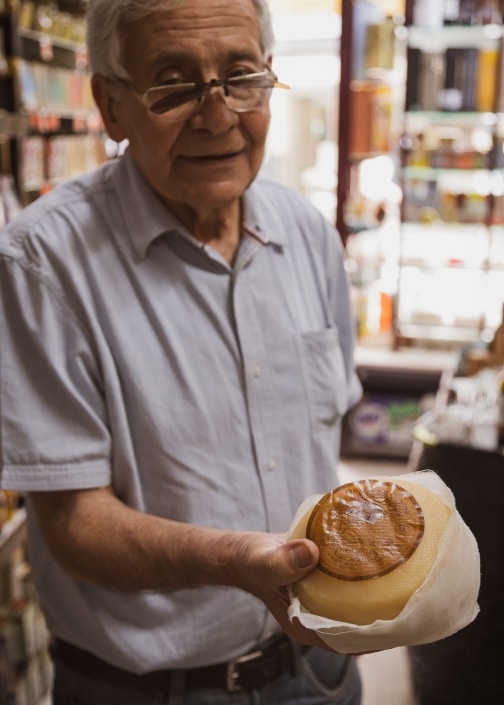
[99,0,269,220]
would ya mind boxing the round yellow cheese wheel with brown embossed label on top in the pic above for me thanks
[291,478,451,625]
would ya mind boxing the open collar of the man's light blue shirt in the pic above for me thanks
[114,151,287,259]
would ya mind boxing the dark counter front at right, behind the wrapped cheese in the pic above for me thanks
[409,442,504,705]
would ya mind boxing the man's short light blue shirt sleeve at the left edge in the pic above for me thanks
[0,256,111,491]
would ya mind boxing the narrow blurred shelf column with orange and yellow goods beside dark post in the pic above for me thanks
[336,0,406,346]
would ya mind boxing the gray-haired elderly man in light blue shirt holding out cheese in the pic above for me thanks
[0,0,360,705]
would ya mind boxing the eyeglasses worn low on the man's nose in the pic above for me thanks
[120,69,289,122]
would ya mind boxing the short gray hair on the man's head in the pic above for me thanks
[87,0,274,81]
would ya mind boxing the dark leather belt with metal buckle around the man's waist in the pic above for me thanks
[51,635,309,693]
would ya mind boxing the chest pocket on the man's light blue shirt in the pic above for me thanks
[301,328,348,429]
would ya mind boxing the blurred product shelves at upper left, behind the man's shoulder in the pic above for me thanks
[0,0,107,210]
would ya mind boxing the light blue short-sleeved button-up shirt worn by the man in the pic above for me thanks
[0,154,360,672]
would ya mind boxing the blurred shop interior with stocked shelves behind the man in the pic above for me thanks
[0,0,504,705]
